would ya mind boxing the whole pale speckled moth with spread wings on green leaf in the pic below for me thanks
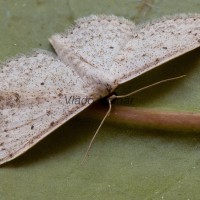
[0,14,200,164]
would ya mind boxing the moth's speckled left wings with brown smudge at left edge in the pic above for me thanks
[0,51,94,164]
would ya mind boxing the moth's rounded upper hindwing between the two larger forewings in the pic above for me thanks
[49,15,135,83]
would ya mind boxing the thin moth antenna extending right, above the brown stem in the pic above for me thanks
[115,75,186,99]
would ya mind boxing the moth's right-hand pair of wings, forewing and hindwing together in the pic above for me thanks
[50,14,200,84]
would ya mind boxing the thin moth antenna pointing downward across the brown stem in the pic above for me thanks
[81,98,112,164]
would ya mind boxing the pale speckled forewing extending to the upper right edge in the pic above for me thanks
[112,14,200,84]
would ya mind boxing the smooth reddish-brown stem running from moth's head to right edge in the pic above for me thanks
[83,105,200,132]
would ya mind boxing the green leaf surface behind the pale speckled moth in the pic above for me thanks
[0,0,200,200]
